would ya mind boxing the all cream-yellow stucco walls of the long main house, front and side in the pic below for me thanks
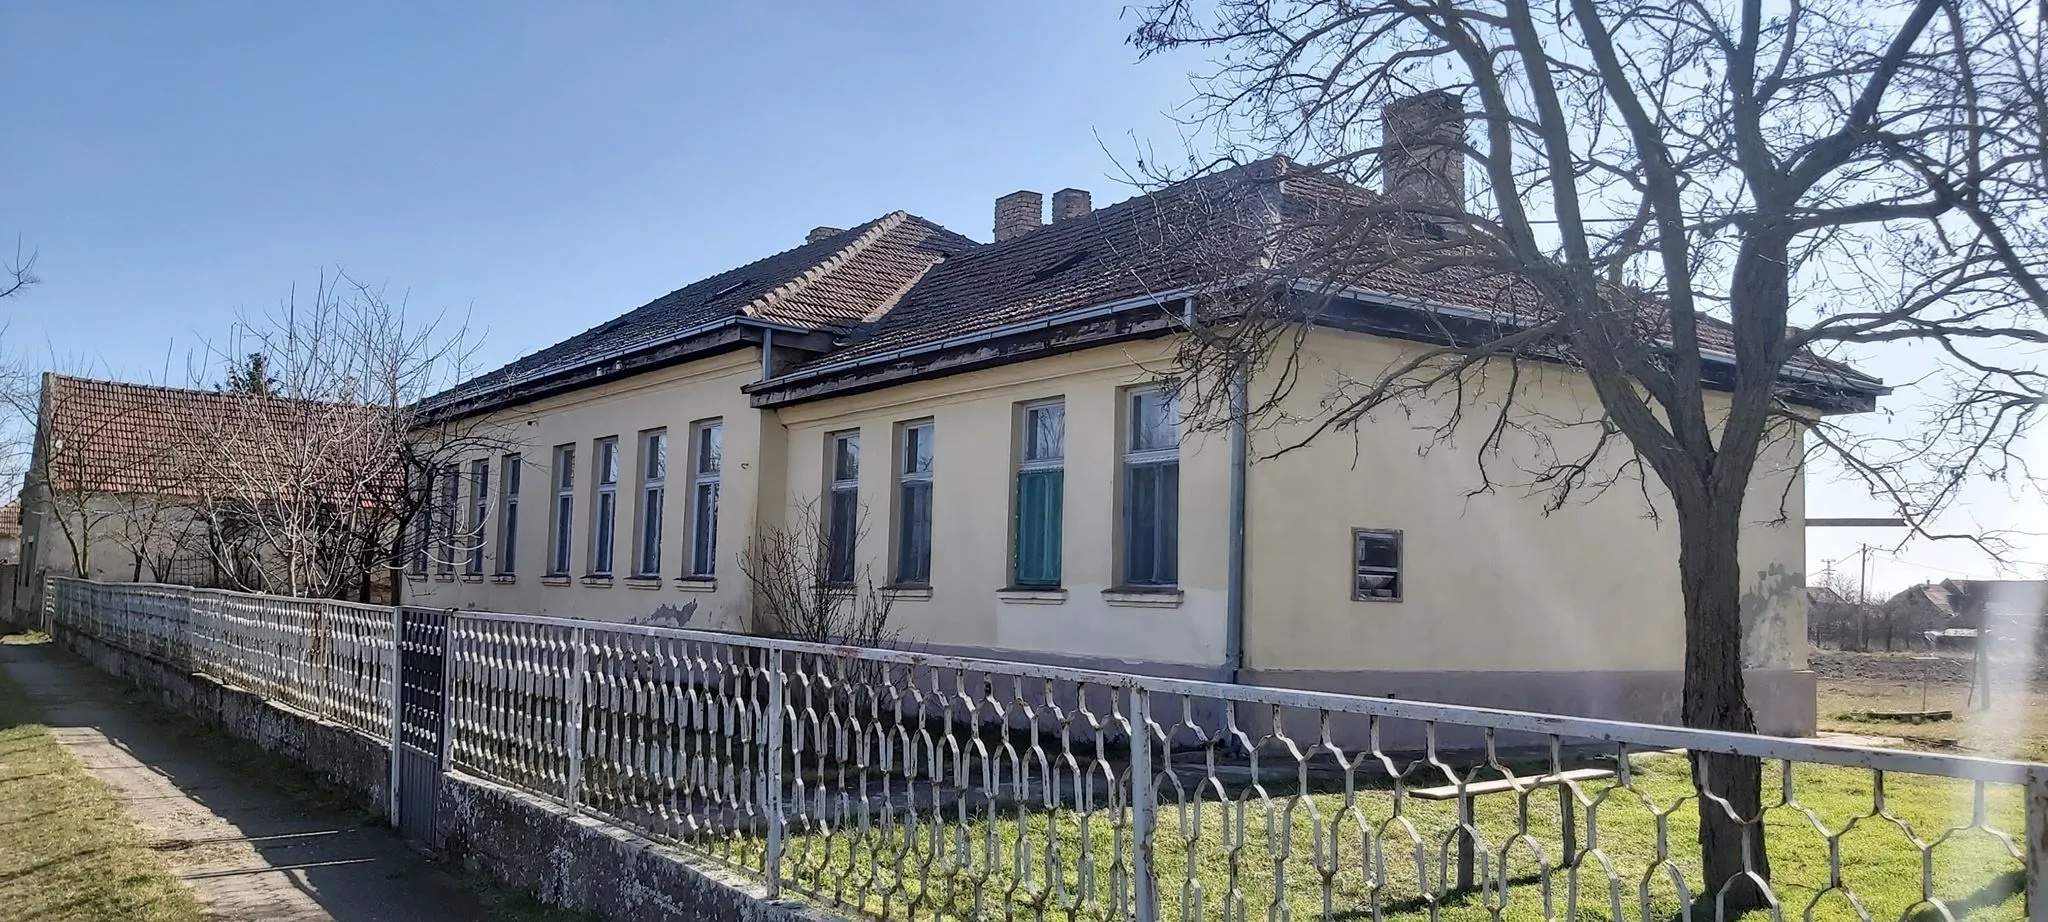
[408,323,1804,672]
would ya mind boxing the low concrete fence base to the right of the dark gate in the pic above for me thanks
[440,774,840,922]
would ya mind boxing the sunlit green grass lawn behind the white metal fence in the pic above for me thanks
[784,754,2023,922]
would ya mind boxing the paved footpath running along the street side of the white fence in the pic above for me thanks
[0,643,571,922]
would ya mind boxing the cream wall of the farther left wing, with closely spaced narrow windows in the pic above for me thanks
[403,348,762,629]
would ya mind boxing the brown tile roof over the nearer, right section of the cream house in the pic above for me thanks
[795,158,1878,393]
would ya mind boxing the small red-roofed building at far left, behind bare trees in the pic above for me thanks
[18,375,389,604]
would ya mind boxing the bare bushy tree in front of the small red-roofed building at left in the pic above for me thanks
[193,273,504,600]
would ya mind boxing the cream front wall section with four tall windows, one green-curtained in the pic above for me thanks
[778,342,1229,666]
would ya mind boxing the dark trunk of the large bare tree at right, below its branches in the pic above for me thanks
[1679,502,1772,918]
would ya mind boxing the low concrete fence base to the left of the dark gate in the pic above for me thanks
[53,627,391,815]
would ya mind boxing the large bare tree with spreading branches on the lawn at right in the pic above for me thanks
[1133,0,2048,912]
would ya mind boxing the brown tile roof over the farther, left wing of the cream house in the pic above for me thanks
[426,211,975,406]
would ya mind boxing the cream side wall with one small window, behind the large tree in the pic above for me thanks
[1245,332,1806,672]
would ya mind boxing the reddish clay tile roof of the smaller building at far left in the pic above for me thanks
[37,375,381,496]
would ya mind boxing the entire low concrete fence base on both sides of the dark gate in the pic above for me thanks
[53,625,840,922]
